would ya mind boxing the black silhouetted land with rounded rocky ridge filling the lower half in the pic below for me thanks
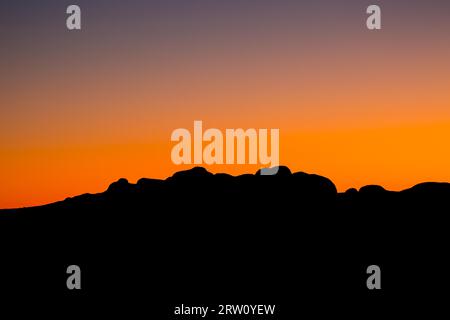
[0,167,450,319]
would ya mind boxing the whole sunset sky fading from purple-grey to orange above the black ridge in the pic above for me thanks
[0,0,450,208]
